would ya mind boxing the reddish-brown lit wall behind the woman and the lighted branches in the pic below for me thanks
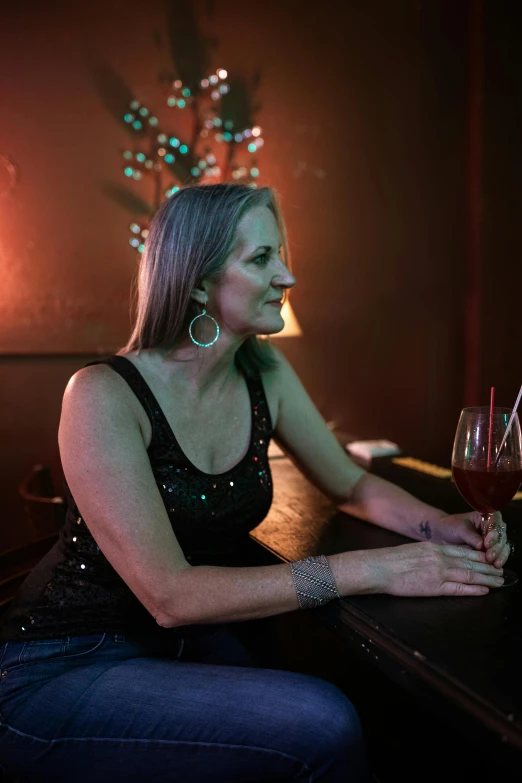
[0,0,522,547]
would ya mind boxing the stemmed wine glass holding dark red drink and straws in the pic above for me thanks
[451,406,522,587]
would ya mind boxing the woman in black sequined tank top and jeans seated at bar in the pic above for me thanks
[0,184,509,783]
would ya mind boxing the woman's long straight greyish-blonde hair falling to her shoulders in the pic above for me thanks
[124,183,290,375]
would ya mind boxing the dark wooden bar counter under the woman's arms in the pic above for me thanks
[251,457,522,783]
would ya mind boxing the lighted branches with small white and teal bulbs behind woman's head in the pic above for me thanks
[122,68,264,253]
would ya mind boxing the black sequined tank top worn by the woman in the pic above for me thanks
[0,356,272,641]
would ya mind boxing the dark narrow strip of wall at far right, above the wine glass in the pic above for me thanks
[480,0,522,406]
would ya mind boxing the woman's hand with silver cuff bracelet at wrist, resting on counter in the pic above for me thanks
[365,542,504,596]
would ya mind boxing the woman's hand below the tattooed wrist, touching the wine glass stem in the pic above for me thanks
[431,511,511,568]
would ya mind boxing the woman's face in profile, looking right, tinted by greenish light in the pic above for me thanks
[208,207,295,335]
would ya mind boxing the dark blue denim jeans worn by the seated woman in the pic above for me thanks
[0,626,367,783]
